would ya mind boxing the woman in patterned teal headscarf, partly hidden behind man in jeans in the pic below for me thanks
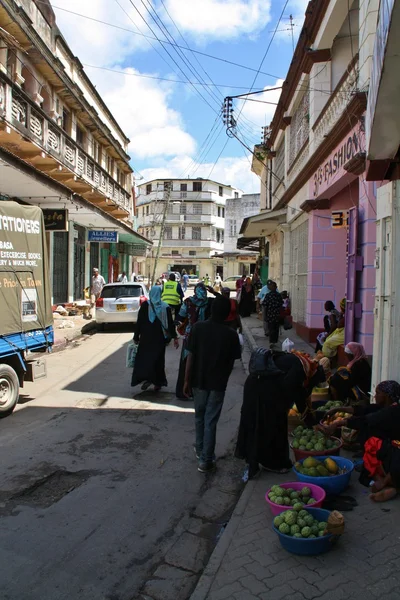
[175,282,214,400]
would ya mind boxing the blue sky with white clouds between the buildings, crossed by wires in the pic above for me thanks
[52,0,307,193]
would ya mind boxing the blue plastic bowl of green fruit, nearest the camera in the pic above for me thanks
[273,508,339,556]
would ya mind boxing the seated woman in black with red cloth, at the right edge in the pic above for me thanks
[326,380,400,502]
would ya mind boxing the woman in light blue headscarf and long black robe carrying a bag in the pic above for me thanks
[131,285,179,392]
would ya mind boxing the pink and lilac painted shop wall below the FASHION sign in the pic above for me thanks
[306,180,358,331]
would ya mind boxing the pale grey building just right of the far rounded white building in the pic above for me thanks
[223,194,260,278]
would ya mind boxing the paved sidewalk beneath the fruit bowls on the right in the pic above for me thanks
[190,317,400,600]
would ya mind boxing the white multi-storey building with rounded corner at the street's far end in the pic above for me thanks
[136,177,242,278]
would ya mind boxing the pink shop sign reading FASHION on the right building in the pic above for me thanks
[311,124,362,198]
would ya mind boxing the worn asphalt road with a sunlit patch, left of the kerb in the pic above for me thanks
[0,331,244,600]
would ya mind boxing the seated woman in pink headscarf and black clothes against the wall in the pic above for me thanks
[329,342,372,403]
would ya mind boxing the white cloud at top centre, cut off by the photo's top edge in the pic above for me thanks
[162,0,271,40]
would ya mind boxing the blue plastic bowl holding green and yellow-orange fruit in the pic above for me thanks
[293,456,354,495]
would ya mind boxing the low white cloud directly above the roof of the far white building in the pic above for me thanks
[138,156,261,194]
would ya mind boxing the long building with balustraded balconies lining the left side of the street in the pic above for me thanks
[0,0,149,303]
